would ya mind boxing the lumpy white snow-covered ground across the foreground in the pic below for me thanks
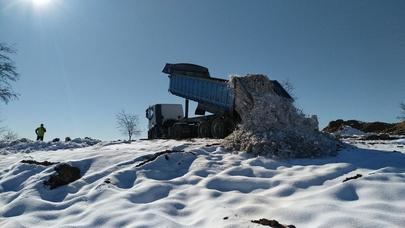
[0,140,405,228]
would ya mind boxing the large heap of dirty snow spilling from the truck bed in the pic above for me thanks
[224,75,341,158]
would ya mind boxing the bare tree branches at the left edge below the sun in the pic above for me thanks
[0,43,18,103]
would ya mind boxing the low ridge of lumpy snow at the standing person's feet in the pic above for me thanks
[0,137,101,154]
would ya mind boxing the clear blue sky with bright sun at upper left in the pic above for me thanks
[0,0,405,139]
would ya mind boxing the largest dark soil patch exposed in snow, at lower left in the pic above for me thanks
[44,164,81,189]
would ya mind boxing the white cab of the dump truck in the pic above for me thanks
[146,104,184,139]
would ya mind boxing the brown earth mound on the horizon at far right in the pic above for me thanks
[322,119,405,135]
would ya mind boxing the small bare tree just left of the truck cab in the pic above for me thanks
[117,110,141,141]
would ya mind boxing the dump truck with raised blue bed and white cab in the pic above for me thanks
[146,63,292,139]
